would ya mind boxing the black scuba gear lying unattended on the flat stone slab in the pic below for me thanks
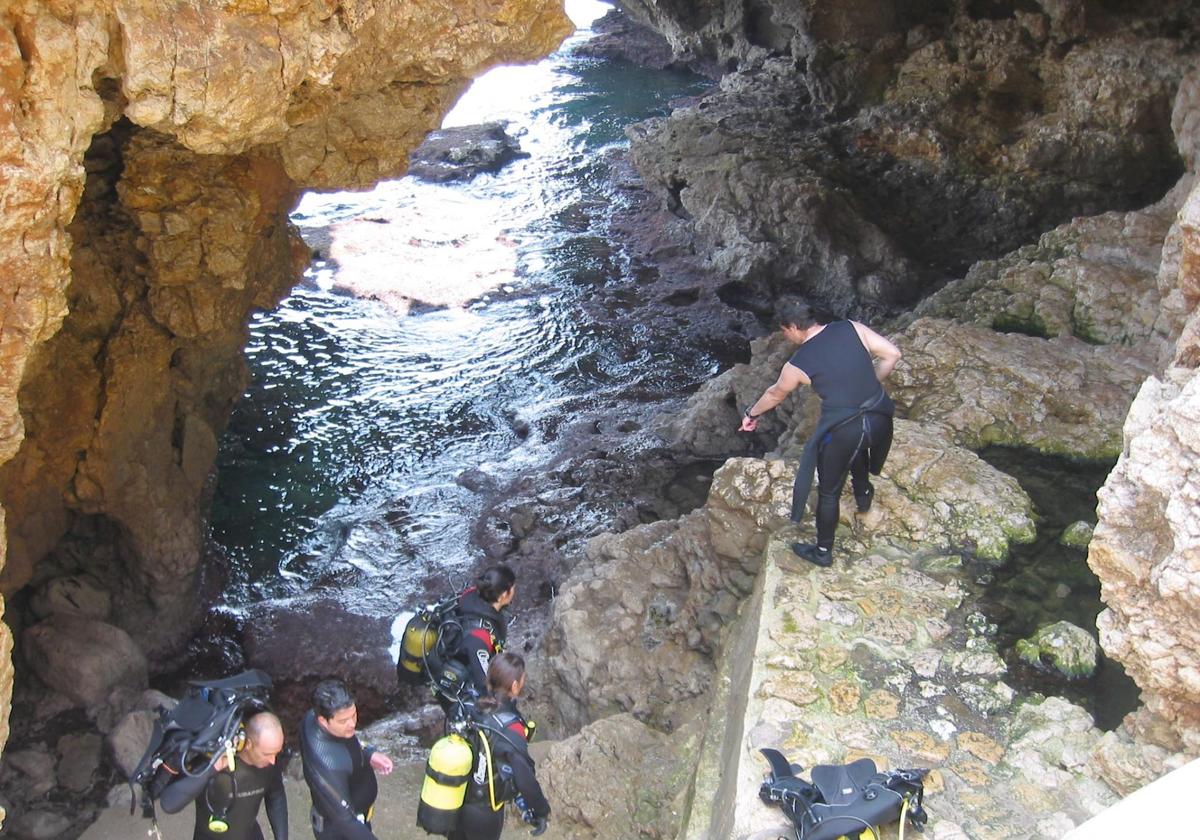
[758,749,929,840]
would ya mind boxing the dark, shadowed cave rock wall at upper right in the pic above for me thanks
[629,0,1200,319]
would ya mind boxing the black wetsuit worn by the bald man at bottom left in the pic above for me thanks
[158,760,288,840]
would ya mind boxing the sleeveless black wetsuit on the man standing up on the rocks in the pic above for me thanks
[788,320,895,548]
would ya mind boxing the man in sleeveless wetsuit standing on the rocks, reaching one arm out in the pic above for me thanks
[740,300,900,566]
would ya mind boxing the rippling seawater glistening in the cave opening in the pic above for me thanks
[210,0,716,613]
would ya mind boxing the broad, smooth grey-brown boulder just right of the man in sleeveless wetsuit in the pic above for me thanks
[888,319,1154,460]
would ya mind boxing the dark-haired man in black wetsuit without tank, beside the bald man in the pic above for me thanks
[300,679,392,840]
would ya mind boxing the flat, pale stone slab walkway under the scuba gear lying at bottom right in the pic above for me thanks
[686,539,1116,840]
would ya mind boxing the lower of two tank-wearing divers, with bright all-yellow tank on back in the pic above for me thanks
[450,652,550,840]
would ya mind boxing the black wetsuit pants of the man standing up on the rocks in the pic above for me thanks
[817,412,892,548]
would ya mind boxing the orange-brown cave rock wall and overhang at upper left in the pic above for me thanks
[0,0,570,746]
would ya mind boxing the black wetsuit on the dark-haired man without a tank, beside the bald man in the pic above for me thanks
[300,709,379,840]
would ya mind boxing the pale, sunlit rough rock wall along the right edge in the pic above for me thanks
[1087,68,1200,758]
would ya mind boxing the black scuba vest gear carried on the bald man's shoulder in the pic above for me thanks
[130,670,271,820]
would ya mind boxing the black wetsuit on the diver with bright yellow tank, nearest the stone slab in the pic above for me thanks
[449,700,550,840]
